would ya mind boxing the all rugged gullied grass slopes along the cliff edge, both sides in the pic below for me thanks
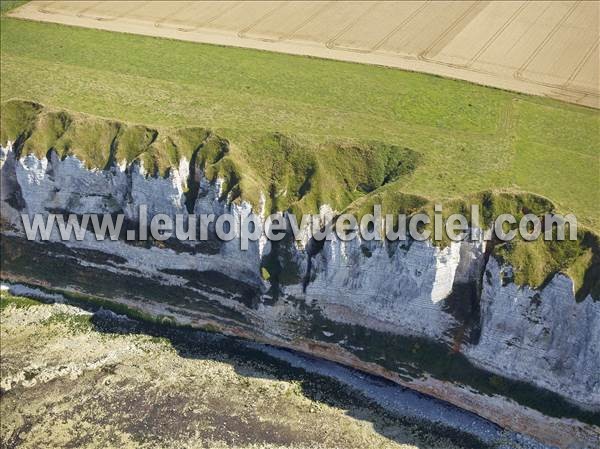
[0,100,600,299]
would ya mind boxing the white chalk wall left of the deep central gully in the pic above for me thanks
[0,147,262,287]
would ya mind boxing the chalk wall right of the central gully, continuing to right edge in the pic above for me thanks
[285,223,600,409]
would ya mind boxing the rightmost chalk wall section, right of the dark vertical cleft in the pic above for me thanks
[464,258,600,406]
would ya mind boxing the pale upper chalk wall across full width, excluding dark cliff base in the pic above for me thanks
[0,147,600,436]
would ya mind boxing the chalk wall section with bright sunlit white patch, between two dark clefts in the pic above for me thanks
[286,237,474,338]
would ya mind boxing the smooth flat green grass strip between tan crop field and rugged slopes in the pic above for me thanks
[0,17,600,232]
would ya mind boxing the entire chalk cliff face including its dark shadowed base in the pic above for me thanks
[1,146,600,447]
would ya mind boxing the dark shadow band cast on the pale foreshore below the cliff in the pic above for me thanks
[77,304,487,448]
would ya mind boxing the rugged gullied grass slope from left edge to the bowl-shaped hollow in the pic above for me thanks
[0,100,421,217]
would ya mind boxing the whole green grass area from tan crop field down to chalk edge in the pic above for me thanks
[1,11,600,294]
